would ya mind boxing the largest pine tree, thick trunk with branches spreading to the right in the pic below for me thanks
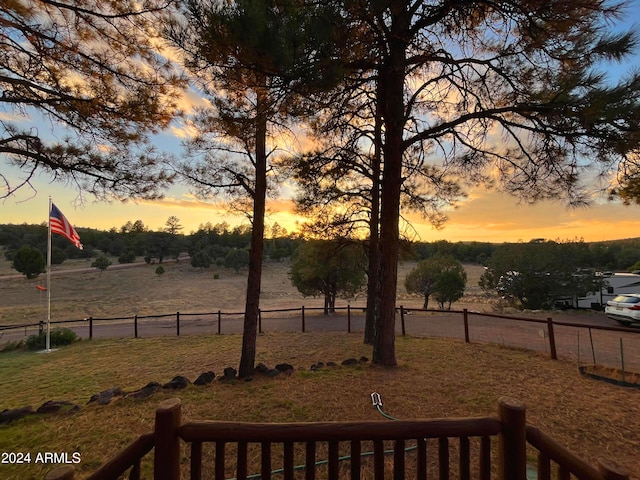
[332,0,640,365]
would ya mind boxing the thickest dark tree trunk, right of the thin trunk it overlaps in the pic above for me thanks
[372,6,411,366]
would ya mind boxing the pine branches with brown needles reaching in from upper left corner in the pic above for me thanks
[0,0,184,198]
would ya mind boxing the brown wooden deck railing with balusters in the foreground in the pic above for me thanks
[45,398,629,480]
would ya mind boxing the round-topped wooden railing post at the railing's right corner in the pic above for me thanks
[498,397,527,480]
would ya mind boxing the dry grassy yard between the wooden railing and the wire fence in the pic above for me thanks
[0,333,640,480]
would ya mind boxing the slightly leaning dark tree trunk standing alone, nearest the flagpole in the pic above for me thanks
[238,92,267,377]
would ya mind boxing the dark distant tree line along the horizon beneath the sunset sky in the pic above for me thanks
[0,217,640,271]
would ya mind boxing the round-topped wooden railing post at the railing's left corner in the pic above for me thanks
[153,398,181,480]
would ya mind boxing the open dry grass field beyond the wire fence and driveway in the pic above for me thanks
[0,258,490,325]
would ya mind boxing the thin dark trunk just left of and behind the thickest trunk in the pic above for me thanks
[364,78,382,345]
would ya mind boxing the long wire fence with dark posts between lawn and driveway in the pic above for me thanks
[0,305,640,373]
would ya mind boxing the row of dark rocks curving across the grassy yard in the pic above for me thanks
[0,357,369,424]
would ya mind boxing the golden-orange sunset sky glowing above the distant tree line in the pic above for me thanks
[0,0,640,242]
